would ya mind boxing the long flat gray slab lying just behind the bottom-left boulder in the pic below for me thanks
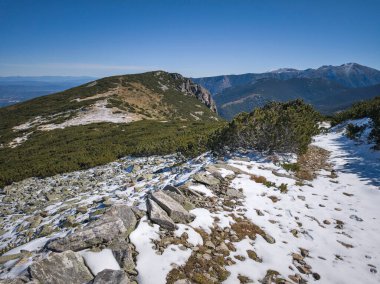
[47,215,128,252]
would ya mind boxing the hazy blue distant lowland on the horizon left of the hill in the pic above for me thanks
[0,76,96,107]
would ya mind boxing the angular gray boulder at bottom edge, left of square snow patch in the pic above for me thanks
[29,251,93,284]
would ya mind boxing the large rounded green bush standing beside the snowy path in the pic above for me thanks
[212,100,320,153]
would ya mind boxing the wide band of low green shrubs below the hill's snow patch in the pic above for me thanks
[0,120,221,187]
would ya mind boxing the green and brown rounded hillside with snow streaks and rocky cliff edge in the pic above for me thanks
[0,71,221,184]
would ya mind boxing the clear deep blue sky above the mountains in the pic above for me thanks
[0,0,380,77]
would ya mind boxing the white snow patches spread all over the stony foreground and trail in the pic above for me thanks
[1,118,380,284]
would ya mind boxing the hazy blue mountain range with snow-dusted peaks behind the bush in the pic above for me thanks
[193,63,380,119]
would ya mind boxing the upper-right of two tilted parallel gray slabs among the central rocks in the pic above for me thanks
[151,191,195,223]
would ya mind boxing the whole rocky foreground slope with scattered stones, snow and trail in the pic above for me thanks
[0,120,380,284]
